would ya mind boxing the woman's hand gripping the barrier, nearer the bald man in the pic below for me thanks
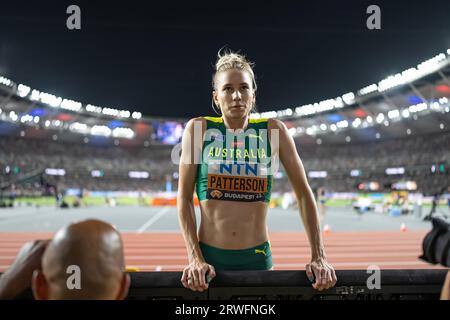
[181,259,216,292]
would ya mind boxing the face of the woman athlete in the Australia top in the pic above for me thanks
[213,69,255,119]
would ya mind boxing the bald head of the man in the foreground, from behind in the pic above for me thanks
[32,220,130,300]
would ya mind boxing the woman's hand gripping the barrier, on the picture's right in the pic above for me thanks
[306,258,337,291]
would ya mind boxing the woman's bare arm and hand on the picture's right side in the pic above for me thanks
[268,119,337,290]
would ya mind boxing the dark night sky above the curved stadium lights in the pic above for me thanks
[0,0,450,117]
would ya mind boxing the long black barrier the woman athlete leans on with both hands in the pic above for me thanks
[2,269,448,301]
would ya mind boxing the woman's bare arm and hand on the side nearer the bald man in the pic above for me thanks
[177,118,216,291]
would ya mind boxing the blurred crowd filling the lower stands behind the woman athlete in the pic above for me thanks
[0,133,450,193]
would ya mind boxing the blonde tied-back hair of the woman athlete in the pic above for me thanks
[212,48,257,113]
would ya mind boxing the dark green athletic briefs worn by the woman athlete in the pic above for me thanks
[199,241,273,271]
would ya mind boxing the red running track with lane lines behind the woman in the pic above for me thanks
[0,231,441,272]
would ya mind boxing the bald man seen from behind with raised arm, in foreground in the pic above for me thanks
[0,220,130,300]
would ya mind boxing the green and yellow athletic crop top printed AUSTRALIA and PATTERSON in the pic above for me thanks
[196,117,272,202]
